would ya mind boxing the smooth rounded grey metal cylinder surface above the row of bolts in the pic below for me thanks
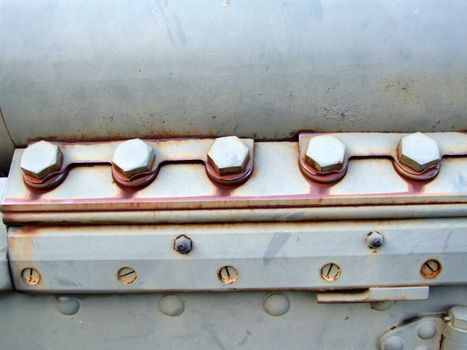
[0,0,467,145]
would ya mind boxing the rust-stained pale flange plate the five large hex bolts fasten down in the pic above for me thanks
[2,133,467,219]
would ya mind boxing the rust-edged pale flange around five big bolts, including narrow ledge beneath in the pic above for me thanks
[1,133,467,224]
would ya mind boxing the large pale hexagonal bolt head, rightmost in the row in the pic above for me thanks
[398,132,441,172]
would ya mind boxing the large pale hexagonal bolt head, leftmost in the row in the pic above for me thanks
[20,141,63,180]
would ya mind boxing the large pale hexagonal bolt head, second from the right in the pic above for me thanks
[305,135,346,173]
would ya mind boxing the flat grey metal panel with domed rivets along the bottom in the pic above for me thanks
[0,286,467,350]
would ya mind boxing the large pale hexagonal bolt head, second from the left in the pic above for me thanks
[112,139,156,178]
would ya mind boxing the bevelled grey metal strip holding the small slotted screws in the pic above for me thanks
[8,219,467,293]
